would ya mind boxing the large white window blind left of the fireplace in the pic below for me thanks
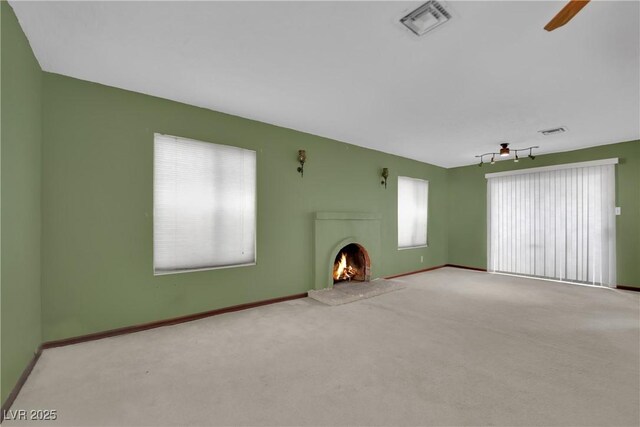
[153,134,256,274]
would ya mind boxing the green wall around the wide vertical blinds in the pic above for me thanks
[447,141,640,287]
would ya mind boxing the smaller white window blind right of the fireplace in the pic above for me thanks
[398,176,429,249]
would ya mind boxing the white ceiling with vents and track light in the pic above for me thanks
[11,1,640,167]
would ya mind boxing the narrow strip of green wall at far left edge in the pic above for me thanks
[0,1,42,402]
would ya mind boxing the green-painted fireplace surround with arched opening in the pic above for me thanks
[315,212,382,289]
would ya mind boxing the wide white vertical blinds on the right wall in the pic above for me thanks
[487,159,617,287]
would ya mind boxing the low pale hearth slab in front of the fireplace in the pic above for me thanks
[308,279,405,305]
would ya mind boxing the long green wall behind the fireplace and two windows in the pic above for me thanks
[42,73,447,340]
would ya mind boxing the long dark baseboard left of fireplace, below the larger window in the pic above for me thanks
[42,292,307,350]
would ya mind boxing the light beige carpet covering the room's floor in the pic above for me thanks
[3,268,640,426]
